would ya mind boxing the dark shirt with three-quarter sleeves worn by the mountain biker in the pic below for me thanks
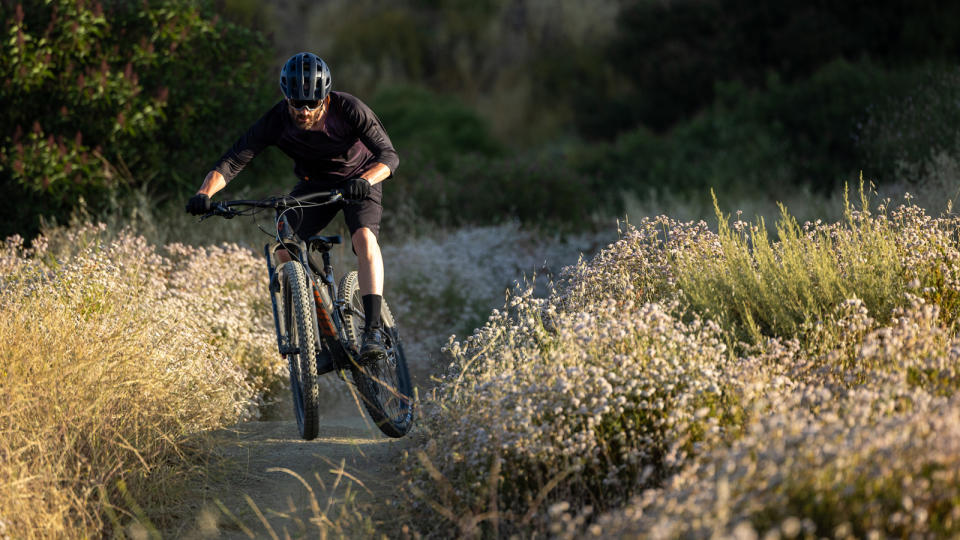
[214,92,400,188]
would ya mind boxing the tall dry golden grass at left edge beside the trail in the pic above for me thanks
[0,226,274,538]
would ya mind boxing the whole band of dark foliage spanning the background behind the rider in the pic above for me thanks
[11,0,960,232]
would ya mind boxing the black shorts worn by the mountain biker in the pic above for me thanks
[287,181,383,240]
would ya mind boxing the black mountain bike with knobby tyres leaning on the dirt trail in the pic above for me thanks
[200,190,413,440]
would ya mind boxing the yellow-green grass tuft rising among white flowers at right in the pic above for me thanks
[676,185,921,342]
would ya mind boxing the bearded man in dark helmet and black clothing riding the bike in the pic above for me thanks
[187,52,400,361]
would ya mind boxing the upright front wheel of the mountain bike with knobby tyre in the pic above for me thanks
[277,261,320,440]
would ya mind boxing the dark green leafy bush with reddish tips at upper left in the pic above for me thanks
[0,0,269,237]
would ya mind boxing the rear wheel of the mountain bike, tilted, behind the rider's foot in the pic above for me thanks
[339,272,413,437]
